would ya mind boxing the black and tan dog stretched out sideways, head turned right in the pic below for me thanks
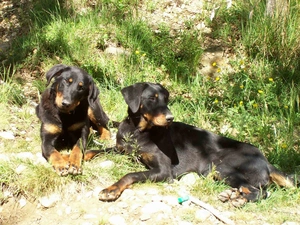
[99,83,293,206]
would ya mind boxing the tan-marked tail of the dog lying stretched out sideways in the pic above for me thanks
[269,164,300,188]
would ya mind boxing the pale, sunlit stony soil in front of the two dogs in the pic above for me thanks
[0,152,237,225]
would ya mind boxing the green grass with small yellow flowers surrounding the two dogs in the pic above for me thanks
[0,0,300,224]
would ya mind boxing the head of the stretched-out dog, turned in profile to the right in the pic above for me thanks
[121,83,174,131]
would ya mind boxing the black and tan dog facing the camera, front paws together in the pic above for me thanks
[36,64,110,176]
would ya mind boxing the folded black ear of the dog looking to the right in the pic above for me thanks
[121,83,148,113]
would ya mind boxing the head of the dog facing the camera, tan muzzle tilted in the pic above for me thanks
[46,64,99,113]
